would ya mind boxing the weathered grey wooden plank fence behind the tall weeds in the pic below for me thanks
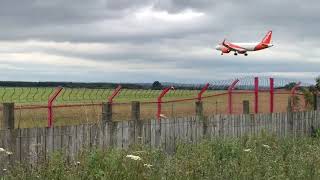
[0,111,320,171]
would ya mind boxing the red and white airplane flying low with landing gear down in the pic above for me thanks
[216,31,273,56]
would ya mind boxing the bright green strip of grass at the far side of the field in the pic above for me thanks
[0,87,219,104]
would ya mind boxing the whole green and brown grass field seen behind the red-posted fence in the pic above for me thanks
[0,88,304,127]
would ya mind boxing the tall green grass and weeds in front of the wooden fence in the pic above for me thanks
[3,134,320,180]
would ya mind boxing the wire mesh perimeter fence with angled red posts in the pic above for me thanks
[0,78,308,128]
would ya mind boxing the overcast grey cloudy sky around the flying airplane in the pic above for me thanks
[0,0,320,83]
